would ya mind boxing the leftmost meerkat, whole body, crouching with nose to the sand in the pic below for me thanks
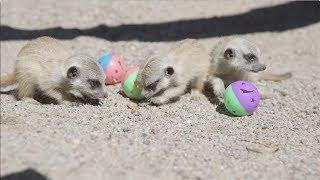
[0,36,107,104]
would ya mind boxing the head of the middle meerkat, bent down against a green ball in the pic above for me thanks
[137,57,175,98]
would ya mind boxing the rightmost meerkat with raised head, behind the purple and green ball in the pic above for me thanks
[209,38,292,98]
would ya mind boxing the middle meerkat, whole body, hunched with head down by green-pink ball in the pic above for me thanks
[137,39,211,105]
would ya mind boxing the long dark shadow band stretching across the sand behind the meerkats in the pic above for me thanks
[0,1,320,42]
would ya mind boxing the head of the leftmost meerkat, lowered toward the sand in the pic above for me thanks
[65,54,107,99]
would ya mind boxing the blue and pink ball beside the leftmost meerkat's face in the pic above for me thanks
[99,53,126,85]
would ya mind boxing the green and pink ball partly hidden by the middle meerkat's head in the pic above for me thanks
[122,67,142,100]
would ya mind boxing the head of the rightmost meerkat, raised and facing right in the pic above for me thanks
[219,38,266,72]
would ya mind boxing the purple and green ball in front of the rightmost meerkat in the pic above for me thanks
[224,81,260,116]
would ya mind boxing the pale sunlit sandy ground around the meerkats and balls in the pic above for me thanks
[1,0,320,179]
